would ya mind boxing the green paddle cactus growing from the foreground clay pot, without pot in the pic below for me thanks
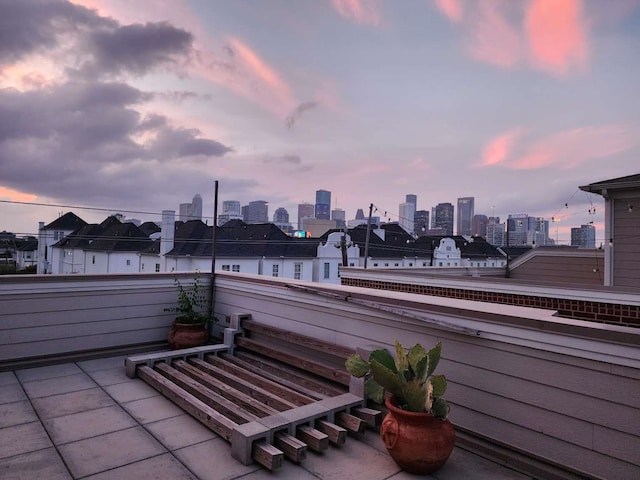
[345,340,449,420]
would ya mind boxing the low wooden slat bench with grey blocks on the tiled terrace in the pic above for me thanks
[125,314,381,470]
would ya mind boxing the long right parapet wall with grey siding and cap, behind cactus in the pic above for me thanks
[216,276,640,480]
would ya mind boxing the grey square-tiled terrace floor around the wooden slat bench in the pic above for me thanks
[0,356,530,480]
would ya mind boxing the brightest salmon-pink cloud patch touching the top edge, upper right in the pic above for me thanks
[525,0,588,75]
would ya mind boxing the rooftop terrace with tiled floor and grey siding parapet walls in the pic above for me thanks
[0,273,640,480]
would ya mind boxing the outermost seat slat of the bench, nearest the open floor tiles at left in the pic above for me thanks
[137,366,237,442]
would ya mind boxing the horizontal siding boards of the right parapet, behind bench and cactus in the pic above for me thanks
[216,277,640,480]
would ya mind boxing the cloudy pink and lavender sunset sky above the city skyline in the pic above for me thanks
[0,0,640,243]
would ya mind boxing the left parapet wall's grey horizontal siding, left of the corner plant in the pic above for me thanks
[0,274,209,365]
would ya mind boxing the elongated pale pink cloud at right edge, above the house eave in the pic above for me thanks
[508,125,640,170]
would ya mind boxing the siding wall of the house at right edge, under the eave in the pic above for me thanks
[613,197,640,288]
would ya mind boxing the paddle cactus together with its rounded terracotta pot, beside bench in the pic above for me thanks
[346,340,455,475]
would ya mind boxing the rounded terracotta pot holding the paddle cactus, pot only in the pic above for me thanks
[380,397,456,475]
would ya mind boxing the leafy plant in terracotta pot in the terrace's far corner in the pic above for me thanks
[164,271,215,350]
